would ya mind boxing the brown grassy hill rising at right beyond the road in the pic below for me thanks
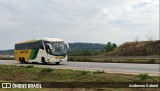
[108,40,160,56]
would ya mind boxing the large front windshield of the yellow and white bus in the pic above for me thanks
[44,42,67,55]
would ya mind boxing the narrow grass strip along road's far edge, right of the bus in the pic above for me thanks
[68,56,160,64]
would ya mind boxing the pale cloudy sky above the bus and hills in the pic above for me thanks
[0,0,159,50]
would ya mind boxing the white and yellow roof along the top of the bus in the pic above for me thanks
[16,38,63,44]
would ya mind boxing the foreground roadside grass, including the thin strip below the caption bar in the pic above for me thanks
[0,65,160,91]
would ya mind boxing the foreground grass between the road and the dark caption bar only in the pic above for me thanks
[0,65,159,82]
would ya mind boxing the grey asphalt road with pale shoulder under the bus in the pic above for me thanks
[0,60,160,76]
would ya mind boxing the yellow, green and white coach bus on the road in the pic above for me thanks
[14,38,69,64]
